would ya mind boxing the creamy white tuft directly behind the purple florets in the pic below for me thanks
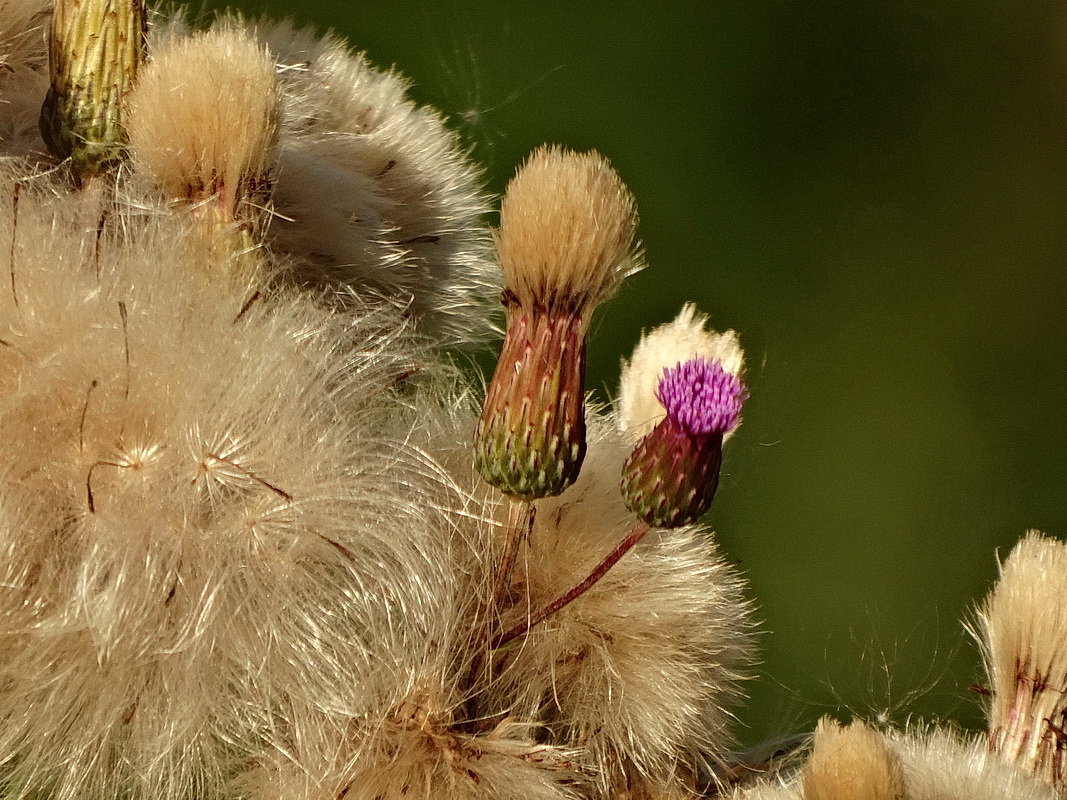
[616,303,745,442]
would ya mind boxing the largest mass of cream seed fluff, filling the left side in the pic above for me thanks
[0,166,469,800]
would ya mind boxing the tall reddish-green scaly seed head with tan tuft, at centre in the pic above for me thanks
[475,147,637,499]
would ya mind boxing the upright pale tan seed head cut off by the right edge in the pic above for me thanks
[976,531,1067,790]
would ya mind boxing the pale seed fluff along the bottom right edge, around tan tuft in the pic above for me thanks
[731,727,1060,800]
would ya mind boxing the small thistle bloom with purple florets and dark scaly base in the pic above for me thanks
[622,358,748,528]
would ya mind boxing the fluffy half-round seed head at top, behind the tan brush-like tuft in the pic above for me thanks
[221,20,499,345]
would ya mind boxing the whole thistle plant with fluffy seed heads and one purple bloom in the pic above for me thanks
[0,0,1067,800]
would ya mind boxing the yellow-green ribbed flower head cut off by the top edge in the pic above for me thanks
[41,0,146,180]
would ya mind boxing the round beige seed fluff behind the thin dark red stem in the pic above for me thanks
[487,417,753,797]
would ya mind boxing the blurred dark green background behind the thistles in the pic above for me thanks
[198,0,1067,741]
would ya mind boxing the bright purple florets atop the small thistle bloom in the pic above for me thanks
[656,357,748,436]
